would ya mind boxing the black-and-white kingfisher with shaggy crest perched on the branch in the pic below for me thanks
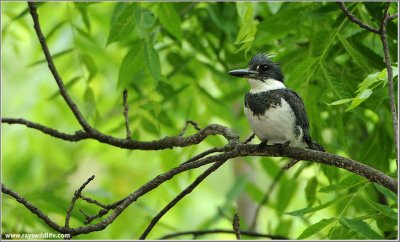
[228,53,325,151]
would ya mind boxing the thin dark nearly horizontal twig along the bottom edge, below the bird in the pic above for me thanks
[159,229,289,240]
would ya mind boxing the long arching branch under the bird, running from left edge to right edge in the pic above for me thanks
[2,144,398,236]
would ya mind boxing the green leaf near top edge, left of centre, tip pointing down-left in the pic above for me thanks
[106,4,136,45]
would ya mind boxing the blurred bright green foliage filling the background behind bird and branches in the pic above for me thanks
[1,2,398,239]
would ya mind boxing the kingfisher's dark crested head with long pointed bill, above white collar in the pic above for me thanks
[228,53,283,83]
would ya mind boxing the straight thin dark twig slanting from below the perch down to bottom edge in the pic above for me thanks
[140,159,226,239]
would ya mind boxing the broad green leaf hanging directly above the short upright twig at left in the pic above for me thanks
[117,42,147,88]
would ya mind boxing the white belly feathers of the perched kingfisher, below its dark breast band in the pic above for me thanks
[244,99,307,147]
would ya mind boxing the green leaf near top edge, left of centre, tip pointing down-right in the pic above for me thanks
[157,3,183,41]
